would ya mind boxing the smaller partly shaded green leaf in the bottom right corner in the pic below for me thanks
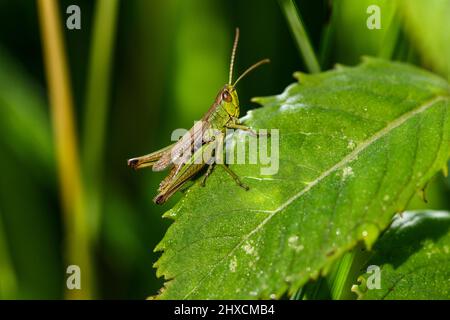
[354,211,450,299]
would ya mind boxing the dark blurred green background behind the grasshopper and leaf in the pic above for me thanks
[0,0,450,299]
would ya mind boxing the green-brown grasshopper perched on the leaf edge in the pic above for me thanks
[128,29,270,204]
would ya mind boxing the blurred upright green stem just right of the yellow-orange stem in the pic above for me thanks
[82,0,119,237]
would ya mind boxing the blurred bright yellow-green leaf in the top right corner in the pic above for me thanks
[401,0,450,77]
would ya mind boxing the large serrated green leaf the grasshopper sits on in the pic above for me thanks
[156,58,450,299]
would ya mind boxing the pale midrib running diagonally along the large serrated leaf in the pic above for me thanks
[183,96,449,299]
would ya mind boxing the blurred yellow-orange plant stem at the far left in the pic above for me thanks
[37,0,93,299]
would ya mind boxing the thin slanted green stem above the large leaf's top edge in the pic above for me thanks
[279,0,320,73]
